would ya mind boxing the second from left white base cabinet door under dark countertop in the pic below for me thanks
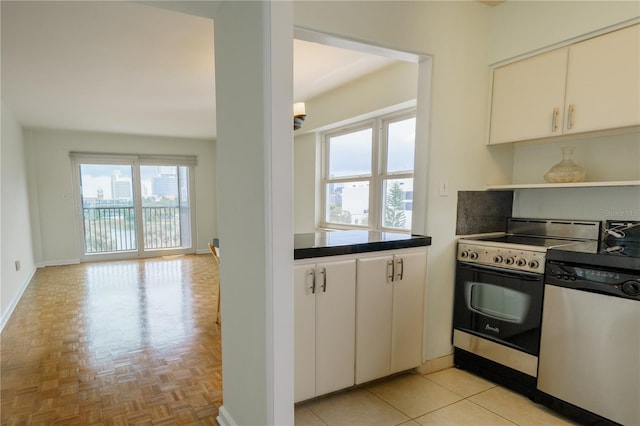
[315,260,356,395]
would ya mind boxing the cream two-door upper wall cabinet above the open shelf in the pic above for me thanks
[489,25,640,144]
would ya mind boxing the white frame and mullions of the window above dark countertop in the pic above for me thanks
[318,107,417,233]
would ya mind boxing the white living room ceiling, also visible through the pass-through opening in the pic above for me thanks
[1,0,394,138]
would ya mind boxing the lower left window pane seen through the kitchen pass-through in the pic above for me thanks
[325,181,369,226]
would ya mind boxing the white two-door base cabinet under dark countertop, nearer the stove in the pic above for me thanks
[355,247,426,384]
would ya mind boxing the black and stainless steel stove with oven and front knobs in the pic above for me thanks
[452,218,600,396]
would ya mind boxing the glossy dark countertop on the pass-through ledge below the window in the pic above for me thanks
[293,230,431,259]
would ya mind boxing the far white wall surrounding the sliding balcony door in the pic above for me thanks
[25,129,217,265]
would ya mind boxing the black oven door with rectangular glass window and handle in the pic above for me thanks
[453,262,544,357]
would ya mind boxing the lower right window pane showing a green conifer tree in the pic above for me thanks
[382,178,413,230]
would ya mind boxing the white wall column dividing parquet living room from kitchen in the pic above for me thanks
[214,1,293,425]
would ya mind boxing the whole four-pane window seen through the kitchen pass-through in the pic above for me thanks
[321,111,416,231]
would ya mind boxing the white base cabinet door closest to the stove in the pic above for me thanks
[391,250,427,373]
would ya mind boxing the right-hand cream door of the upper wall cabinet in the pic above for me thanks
[565,25,640,133]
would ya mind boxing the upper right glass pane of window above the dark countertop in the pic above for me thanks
[387,117,416,173]
